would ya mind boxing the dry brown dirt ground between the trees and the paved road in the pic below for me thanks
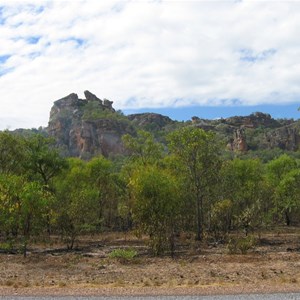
[0,228,300,295]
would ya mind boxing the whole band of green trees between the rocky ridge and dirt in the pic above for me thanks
[0,127,300,255]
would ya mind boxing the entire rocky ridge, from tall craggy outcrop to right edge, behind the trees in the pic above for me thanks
[47,91,300,159]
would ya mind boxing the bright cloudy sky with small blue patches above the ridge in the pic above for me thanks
[0,0,300,129]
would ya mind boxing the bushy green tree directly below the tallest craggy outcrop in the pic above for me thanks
[55,158,99,249]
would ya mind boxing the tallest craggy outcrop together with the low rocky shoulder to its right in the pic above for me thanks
[47,91,178,159]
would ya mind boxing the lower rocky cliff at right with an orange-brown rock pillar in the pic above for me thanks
[191,112,300,152]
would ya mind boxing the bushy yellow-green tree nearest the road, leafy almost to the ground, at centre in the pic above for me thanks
[130,166,181,256]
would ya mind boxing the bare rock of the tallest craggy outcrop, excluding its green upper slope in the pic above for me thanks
[47,91,133,159]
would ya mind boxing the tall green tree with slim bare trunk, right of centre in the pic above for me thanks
[168,127,220,240]
